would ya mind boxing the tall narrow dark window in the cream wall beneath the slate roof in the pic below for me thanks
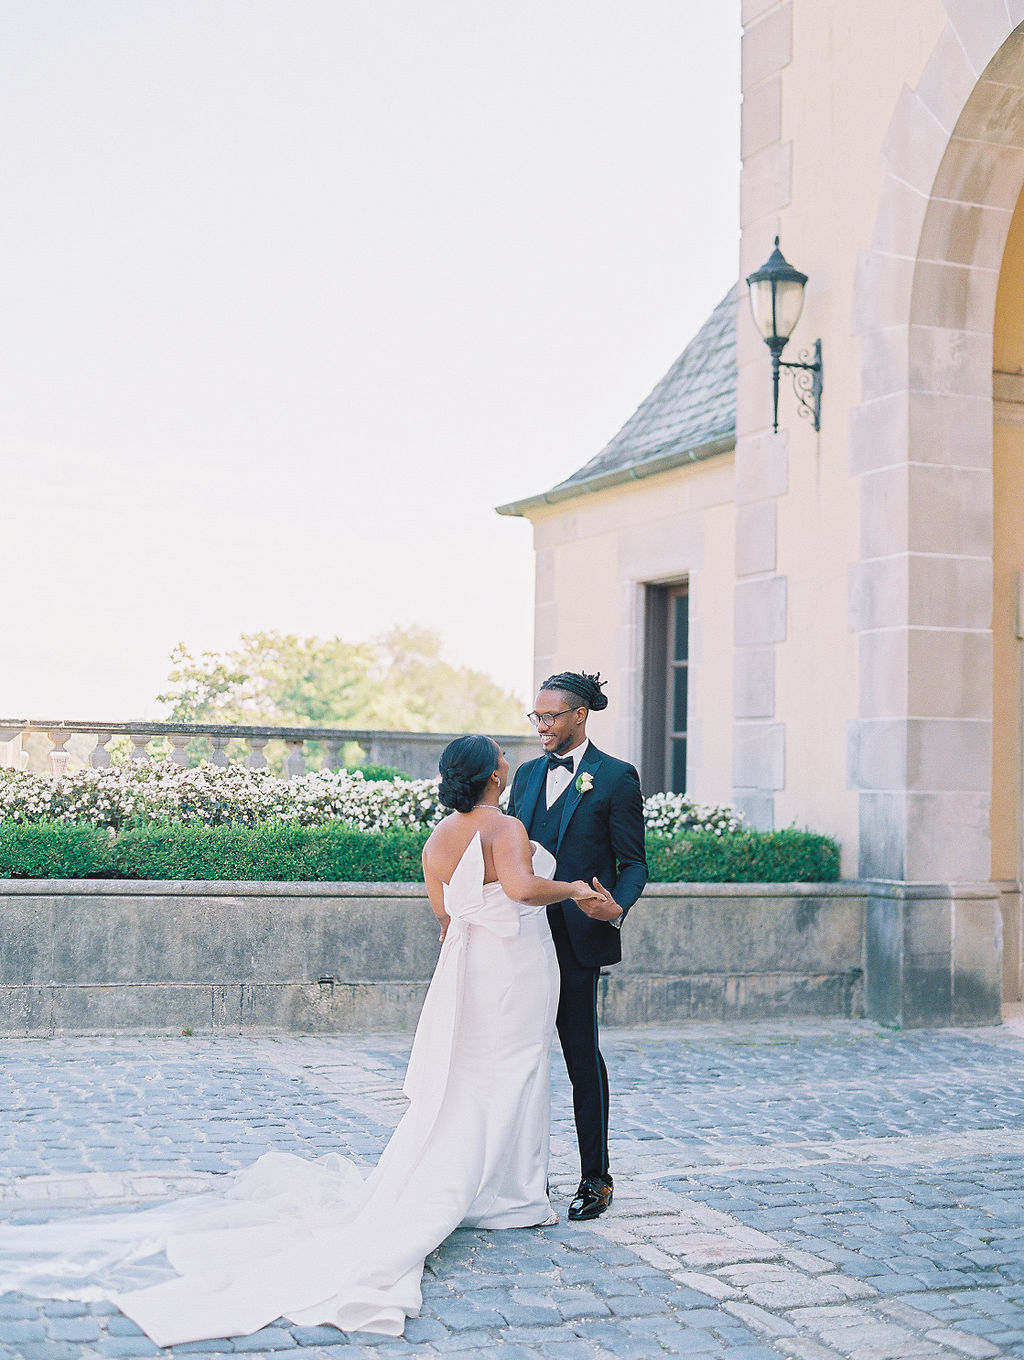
[643,583,689,793]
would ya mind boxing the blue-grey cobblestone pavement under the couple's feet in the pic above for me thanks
[0,1019,1024,1360]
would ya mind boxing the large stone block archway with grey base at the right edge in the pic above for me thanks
[850,10,1024,1024]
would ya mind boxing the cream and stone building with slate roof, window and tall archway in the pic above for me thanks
[502,0,1024,1024]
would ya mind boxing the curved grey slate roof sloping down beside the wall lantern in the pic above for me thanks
[499,284,738,514]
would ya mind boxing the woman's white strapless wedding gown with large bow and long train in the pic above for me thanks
[0,832,558,1346]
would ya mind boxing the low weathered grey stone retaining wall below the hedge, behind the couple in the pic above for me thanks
[0,880,865,1035]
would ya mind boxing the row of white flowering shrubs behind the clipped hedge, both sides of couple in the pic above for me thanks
[0,760,741,835]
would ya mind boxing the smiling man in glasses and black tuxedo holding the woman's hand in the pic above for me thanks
[509,670,647,1220]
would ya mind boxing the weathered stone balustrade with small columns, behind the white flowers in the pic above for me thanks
[0,718,539,779]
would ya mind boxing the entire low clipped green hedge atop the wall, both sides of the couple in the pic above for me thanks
[0,821,839,883]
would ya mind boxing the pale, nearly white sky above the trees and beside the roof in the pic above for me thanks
[0,0,740,719]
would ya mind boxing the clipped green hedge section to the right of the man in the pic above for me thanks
[647,827,839,883]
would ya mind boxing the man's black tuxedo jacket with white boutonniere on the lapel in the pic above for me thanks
[509,743,647,968]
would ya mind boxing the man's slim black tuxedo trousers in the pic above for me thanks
[548,906,608,1176]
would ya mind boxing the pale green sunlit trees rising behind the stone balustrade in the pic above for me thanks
[156,628,524,733]
